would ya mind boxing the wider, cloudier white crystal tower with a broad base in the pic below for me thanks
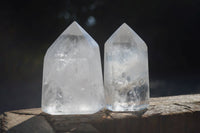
[42,22,105,115]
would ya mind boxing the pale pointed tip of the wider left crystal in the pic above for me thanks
[62,21,86,36]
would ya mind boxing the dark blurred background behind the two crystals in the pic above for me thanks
[0,0,200,113]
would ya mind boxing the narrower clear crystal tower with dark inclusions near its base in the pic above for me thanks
[104,23,149,111]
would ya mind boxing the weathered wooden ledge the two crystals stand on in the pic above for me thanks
[0,94,200,133]
